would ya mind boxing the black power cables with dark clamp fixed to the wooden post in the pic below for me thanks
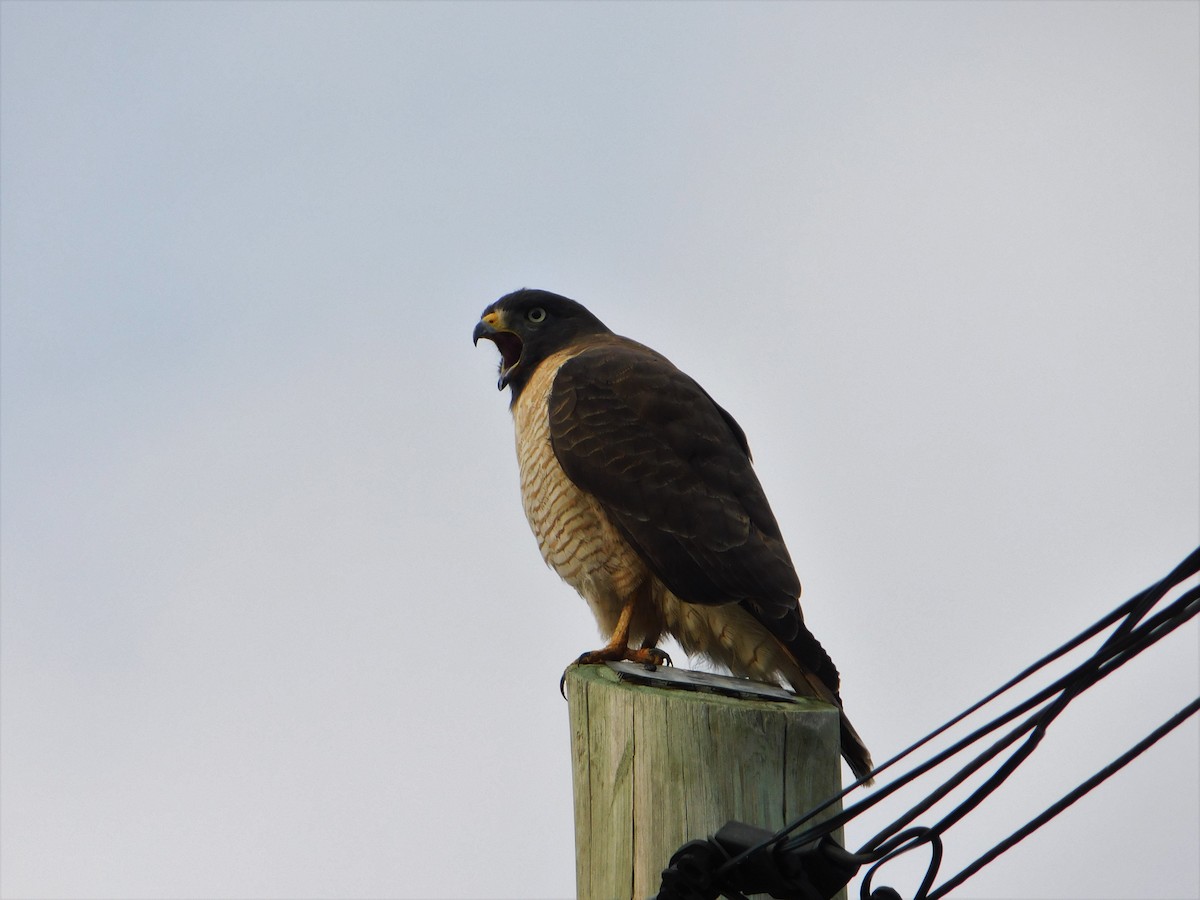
[658,548,1200,900]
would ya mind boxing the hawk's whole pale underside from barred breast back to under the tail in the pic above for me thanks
[512,348,811,694]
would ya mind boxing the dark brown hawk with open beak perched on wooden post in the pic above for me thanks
[474,290,872,778]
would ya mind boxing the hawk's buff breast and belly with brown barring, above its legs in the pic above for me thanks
[512,350,650,637]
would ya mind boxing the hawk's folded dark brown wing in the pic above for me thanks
[550,336,839,696]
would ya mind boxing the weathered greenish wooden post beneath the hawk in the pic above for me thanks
[566,662,845,900]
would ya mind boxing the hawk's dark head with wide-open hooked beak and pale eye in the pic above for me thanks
[472,288,612,398]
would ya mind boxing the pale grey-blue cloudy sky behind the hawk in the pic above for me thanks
[0,0,1200,899]
